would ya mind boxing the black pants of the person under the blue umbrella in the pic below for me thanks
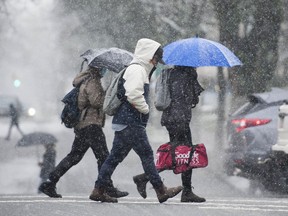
[165,123,192,190]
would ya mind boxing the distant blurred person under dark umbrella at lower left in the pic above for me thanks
[38,143,56,193]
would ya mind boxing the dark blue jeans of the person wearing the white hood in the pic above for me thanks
[95,125,163,189]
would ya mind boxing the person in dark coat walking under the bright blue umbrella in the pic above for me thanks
[133,66,206,202]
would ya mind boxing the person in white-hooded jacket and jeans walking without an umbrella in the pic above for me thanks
[90,38,182,203]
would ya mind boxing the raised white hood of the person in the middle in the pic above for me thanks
[131,38,161,73]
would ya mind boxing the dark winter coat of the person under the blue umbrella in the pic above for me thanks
[161,67,204,126]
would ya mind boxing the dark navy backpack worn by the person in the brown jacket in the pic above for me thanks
[61,76,90,128]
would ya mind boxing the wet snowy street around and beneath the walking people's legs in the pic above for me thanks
[0,112,288,216]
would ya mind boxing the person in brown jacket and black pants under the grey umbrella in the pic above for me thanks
[39,66,128,198]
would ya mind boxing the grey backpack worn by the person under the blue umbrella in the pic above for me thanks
[154,70,171,111]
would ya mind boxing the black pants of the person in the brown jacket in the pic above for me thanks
[49,125,112,186]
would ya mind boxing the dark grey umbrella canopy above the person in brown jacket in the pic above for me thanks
[81,47,133,73]
